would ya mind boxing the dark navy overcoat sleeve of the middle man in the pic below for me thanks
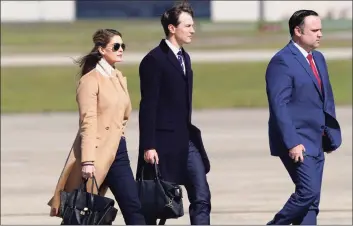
[139,55,162,150]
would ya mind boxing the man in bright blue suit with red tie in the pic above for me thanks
[266,10,342,225]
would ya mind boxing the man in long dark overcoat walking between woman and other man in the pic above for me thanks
[136,2,211,225]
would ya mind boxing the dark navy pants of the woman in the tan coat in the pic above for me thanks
[106,137,146,225]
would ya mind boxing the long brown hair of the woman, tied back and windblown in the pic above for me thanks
[75,29,122,77]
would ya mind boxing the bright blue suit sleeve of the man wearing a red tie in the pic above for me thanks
[266,58,301,150]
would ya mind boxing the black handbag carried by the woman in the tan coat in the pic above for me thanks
[59,177,118,225]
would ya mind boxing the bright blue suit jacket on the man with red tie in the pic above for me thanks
[266,42,342,156]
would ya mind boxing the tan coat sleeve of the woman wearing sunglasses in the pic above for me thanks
[76,76,98,162]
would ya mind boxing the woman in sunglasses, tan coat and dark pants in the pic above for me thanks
[49,29,145,225]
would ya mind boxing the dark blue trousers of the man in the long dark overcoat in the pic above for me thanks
[146,142,211,225]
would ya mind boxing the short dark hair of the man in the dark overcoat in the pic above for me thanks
[161,1,194,36]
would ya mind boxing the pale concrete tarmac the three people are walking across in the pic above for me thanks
[1,106,352,225]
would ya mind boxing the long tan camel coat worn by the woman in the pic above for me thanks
[48,62,131,217]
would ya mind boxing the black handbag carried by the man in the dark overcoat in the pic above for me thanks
[136,163,184,225]
